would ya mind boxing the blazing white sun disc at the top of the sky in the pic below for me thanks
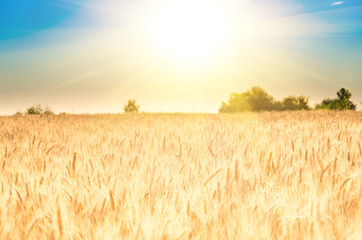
[150,0,231,63]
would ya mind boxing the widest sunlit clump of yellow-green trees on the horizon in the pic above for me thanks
[219,87,310,112]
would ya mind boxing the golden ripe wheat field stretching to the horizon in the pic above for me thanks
[0,111,362,240]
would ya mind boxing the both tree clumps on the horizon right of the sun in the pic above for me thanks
[219,87,356,113]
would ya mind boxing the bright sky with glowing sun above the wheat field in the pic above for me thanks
[0,0,362,114]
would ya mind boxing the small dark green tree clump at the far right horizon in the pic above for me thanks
[315,88,356,110]
